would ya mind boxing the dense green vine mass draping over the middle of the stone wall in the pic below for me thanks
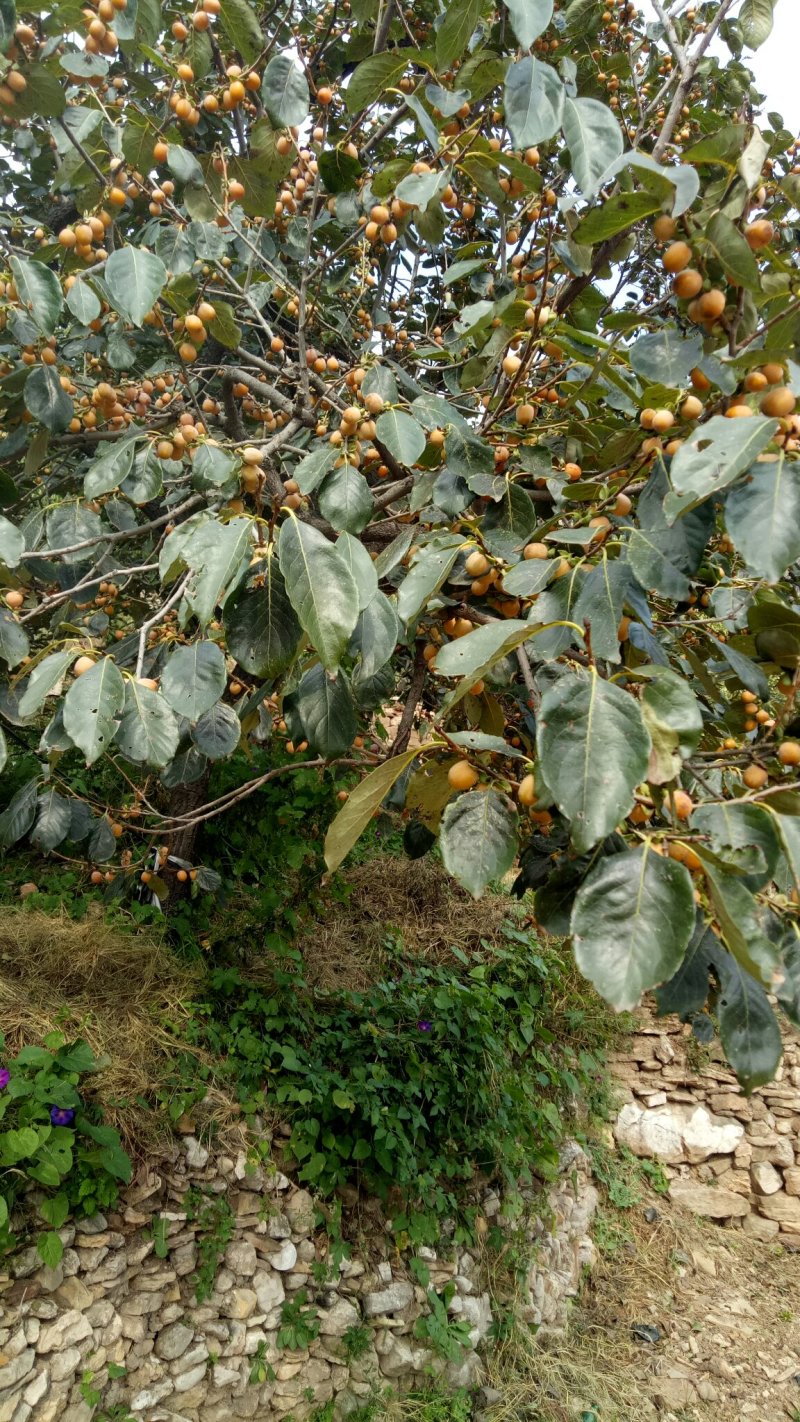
[183,924,593,1241]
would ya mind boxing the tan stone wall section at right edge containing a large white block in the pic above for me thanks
[614,1008,800,1249]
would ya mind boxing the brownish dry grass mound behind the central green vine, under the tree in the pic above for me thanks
[300,855,516,991]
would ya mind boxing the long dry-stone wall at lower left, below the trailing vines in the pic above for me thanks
[0,1138,597,1422]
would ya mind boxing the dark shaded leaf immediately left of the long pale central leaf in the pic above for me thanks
[225,549,303,681]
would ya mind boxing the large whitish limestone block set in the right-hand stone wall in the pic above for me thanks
[614,1101,745,1165]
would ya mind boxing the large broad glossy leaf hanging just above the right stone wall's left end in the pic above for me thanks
[571,846,695,1012]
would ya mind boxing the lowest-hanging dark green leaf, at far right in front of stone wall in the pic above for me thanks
[715,953,783,1092]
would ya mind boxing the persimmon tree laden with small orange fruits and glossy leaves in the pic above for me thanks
[0,0,800,1085]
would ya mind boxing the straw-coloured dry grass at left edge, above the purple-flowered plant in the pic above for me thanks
[0,909,237,1158]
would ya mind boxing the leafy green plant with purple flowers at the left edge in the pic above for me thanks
[0,1032,131,1268]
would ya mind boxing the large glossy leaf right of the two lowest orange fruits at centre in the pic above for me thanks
[537,671,649,853]
